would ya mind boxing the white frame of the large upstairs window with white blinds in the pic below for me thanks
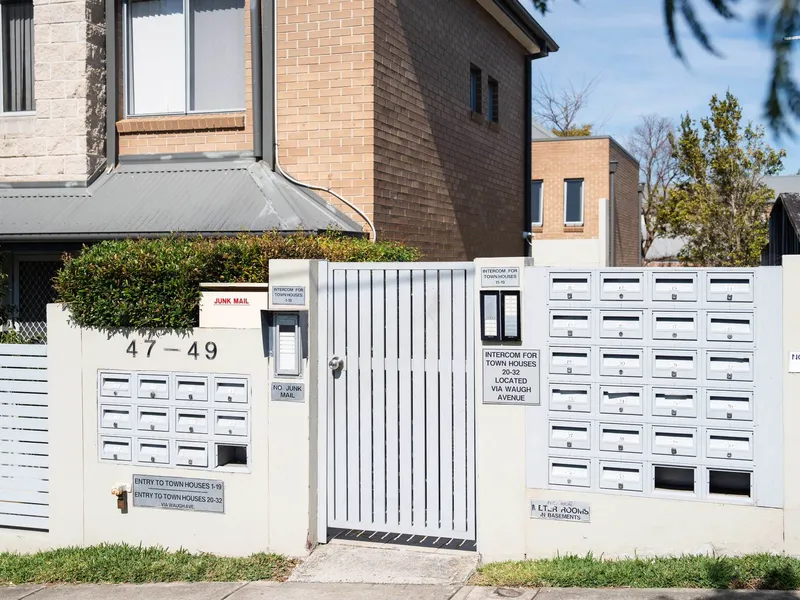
[122,0,247,118]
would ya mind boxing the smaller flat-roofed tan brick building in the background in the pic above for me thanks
[528,136,641,267]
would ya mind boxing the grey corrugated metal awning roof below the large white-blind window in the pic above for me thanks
[0,160,362,241]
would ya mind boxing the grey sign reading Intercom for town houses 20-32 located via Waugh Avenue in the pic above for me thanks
[483,348,541,405]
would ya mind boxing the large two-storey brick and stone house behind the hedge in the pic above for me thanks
[0,0,558,333]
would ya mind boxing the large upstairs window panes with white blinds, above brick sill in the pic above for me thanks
[125,0,245,115]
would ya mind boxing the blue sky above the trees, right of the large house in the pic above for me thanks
[533,0,800,174]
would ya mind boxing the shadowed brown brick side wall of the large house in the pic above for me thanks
[375,0,526,260]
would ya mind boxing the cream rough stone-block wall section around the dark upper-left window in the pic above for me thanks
[0,0,105,182]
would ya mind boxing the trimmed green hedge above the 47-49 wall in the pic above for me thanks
[55,233,420,329]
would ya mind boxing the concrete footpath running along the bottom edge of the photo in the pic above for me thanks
[0,582,800,600]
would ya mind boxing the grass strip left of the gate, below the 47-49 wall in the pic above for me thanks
[0,544,295,585]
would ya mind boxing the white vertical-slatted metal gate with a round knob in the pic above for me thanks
[326,263,475,540]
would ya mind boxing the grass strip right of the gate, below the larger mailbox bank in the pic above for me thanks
[470,554,800,590]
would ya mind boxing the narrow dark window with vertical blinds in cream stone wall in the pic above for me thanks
[0,0,33,112]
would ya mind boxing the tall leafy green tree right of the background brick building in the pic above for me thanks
[656,92,786,267]
